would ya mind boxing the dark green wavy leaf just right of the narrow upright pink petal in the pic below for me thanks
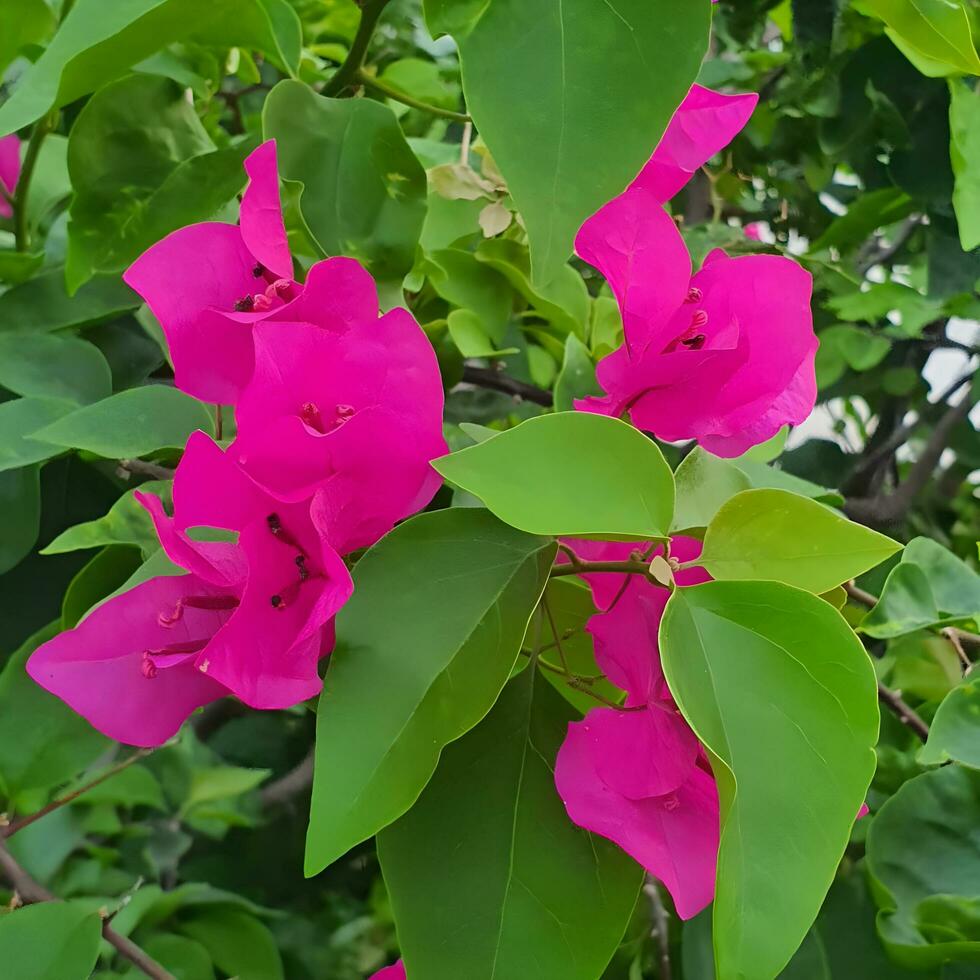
[262,80,426,279]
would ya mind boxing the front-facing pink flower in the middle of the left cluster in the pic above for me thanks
[229,259,446,553]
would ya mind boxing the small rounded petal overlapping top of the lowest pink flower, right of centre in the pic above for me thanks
[582,705,700,800]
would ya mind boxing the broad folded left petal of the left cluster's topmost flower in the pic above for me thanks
[123,222,264,402]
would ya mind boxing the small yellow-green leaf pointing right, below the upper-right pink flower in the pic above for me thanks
[698,490,901,593]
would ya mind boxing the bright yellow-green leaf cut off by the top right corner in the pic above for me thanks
[862,0,980,75]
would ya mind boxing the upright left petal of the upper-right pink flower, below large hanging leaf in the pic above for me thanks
[575,187,691,355]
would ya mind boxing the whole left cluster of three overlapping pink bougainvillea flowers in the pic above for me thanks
[27,141,446,746]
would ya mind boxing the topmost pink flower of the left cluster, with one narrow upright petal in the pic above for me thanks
[123,140,299,403]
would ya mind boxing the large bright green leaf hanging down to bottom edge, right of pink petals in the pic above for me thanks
[660,582,878,980]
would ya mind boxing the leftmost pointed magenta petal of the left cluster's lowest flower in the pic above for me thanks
[27,575,228,746]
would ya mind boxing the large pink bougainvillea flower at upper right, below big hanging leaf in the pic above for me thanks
[576,187,817,456]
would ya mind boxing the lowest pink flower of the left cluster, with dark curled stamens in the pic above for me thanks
[27,432,353,745]
